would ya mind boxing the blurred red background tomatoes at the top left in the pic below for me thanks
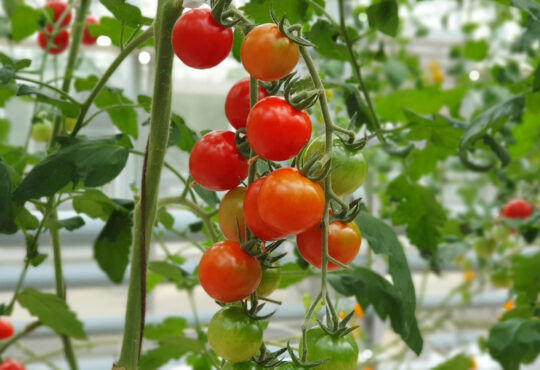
[38,1,98,55]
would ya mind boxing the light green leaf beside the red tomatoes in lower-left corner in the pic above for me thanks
[17,288,86,339]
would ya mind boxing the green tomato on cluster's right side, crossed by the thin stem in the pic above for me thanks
[303,136,368,196]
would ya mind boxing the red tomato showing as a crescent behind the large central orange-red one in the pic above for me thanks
[244,177,287,241]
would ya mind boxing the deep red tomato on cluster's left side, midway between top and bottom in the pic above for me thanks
[189,130,248,191]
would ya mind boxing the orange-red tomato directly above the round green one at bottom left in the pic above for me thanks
[199,240,262,302]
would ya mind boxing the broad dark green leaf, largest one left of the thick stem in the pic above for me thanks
[13,136,129,201]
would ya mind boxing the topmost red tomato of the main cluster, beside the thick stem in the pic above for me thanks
[172,9,233,69]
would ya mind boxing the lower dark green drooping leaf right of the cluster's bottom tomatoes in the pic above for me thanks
[328,267,423,354]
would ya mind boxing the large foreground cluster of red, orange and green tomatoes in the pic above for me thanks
[172,5,367,368]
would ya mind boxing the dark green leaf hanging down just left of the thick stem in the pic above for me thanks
[94,211,133,284]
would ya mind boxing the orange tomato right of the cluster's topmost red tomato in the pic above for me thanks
[240,23,299,81]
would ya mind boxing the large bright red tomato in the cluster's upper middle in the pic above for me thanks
[246,96,311,161]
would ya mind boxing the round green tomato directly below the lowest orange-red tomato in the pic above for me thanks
[208,307,263,363]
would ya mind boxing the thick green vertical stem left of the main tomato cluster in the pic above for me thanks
[116,0,182,370]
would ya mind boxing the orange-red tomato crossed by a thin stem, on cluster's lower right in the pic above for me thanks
[296,221,362,271]
